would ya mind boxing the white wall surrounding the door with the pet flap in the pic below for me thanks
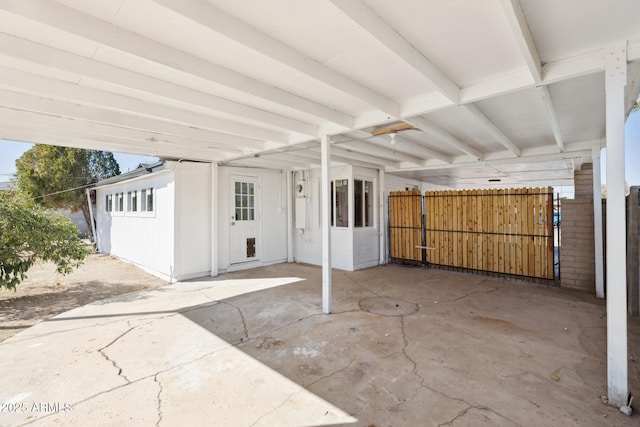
[216,166,287,271]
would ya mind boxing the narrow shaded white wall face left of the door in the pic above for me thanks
[175,162,211,280]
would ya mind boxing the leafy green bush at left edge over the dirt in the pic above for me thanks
[0,191,89,290]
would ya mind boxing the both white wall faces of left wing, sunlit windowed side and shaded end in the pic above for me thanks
[95,162,211,281]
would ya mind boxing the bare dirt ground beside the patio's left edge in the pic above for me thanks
[0,254,167,342]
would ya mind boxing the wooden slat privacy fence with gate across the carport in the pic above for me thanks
[389,187,554,280]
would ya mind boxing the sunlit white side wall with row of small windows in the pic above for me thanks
[95,171,175,280]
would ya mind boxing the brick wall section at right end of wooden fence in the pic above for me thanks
[560,164,596,292]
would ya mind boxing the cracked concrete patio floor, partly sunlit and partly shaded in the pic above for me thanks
[0,264,640,427]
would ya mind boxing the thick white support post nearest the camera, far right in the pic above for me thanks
[605,44,629,407]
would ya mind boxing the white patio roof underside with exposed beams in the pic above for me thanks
[0,0,640,188]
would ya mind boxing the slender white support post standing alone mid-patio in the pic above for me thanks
[320,135,331,314]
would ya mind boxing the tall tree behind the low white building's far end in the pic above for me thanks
[16,145,120,236]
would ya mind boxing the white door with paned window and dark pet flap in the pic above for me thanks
[229,175,261,264]
